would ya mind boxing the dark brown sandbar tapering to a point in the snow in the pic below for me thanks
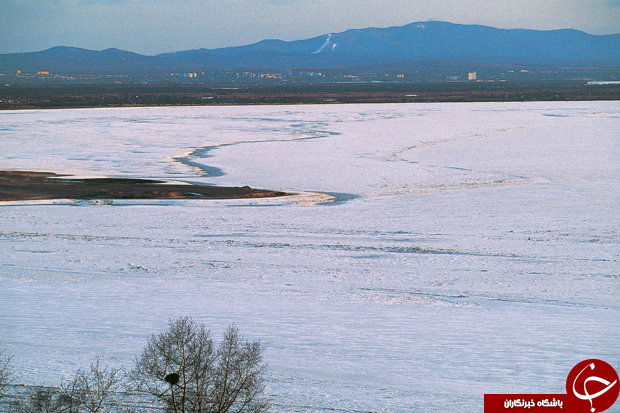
[0,171,291,201]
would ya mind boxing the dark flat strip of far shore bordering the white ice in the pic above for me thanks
[0,80,620,109]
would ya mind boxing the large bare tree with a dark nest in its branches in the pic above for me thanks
[130,317,265,413]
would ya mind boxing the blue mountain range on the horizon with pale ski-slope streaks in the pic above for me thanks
[0,21,620,73]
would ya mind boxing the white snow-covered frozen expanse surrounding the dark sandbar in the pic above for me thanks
[0,102,620,412]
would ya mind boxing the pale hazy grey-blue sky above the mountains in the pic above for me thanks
[0,0,620,54]
